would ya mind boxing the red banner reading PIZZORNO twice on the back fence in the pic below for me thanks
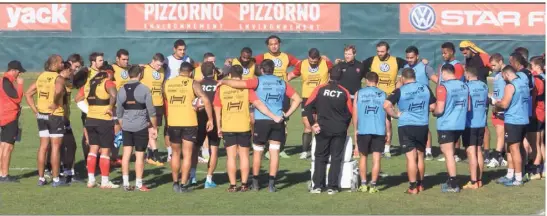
[125,4,340,32]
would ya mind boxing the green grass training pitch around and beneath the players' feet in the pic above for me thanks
[0,73,545,215]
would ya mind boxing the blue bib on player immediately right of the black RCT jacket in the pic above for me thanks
[355,87,386,135]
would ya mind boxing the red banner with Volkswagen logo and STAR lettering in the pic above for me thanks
[399,4,545,35]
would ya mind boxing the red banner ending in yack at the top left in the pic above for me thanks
[0,4,71,31]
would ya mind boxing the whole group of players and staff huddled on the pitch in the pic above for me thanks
[0,35,545,194]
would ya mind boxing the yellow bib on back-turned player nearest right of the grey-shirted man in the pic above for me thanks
[164,76,198,127]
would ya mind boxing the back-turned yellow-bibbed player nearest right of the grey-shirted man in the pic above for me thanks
[163,62,214,193]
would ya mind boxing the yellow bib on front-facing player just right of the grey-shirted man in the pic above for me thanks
[141,65,165,106]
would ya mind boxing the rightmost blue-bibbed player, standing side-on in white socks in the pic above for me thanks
[491,65,530,186]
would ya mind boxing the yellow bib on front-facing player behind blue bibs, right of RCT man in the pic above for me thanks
[370,56,399,94]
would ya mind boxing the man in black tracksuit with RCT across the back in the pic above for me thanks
[305,66,352,194]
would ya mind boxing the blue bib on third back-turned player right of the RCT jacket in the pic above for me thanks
[437,79,469,130]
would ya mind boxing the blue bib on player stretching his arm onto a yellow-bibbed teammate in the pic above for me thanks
[254,74,287,120]
